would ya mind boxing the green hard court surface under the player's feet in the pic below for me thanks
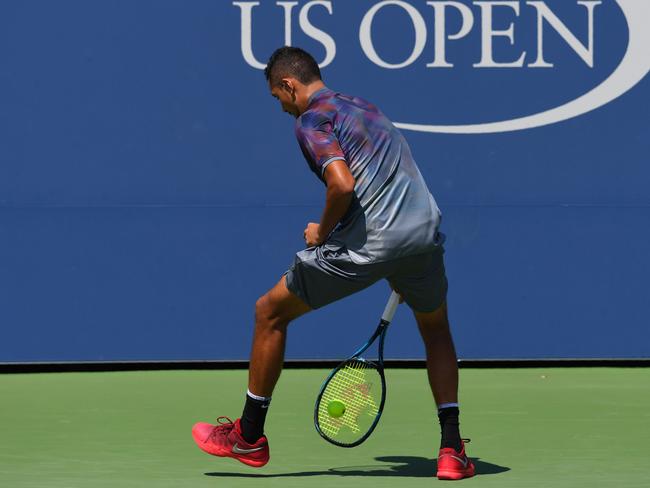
[0,368,650,488]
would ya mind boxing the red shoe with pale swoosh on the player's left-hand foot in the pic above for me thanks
[192,417,270,468]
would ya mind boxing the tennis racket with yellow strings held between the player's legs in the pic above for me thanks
[314,292,400,447]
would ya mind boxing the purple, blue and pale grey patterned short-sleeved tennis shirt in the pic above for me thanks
[296,88,441,264]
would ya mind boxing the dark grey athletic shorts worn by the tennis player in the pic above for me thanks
[285,245,447,312]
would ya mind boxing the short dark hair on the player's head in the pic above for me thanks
[264,46,321,86]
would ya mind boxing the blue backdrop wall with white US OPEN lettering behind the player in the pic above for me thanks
[0,0,650,362]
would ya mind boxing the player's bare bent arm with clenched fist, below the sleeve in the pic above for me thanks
[305,159,354,246]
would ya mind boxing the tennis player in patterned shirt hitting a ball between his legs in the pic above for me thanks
[192,47,474,479]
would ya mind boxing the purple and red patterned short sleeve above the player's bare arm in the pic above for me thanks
[296,113,345,179]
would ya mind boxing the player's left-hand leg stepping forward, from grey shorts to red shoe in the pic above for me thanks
[192,246,384,467]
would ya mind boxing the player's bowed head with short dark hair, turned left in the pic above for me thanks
[264,46,323,117]
